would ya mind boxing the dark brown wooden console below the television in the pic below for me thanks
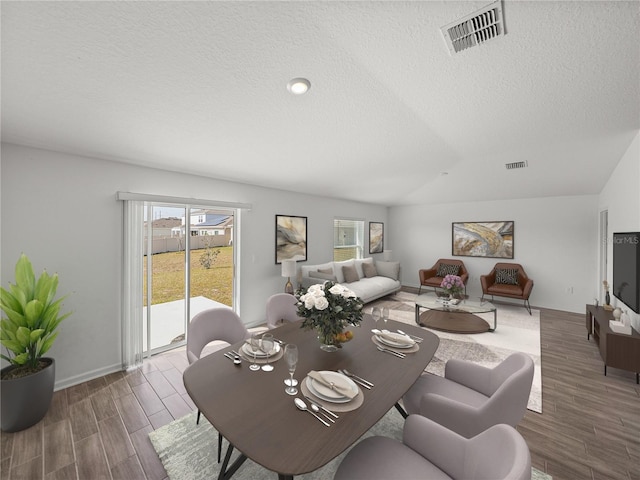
[586,305,640,383]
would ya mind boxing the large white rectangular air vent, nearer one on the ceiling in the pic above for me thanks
[440,0,506,55]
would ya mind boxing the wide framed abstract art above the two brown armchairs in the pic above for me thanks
[451,221,513,258]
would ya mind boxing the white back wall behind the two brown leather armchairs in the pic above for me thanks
[389,195,598,313]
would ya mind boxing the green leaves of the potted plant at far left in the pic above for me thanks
[0,253,71,378]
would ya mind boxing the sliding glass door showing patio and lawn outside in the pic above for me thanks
[142,202,236,356]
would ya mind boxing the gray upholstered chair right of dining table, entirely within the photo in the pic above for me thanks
[402,352,534,438]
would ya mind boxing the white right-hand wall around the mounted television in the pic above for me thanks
[597,133,640,330]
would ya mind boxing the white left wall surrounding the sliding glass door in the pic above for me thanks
[0,144,387,388]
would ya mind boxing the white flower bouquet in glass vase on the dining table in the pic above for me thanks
[296,282,363,351]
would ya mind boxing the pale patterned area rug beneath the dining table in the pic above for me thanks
[149,408,551,480]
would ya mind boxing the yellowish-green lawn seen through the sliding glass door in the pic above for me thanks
[143,247,233,306]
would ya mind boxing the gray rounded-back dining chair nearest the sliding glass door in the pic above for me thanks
[187,307,251,463]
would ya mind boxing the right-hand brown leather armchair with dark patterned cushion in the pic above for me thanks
[480,263,533,315]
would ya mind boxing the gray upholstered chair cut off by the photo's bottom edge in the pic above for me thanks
[333,415,531,480]
